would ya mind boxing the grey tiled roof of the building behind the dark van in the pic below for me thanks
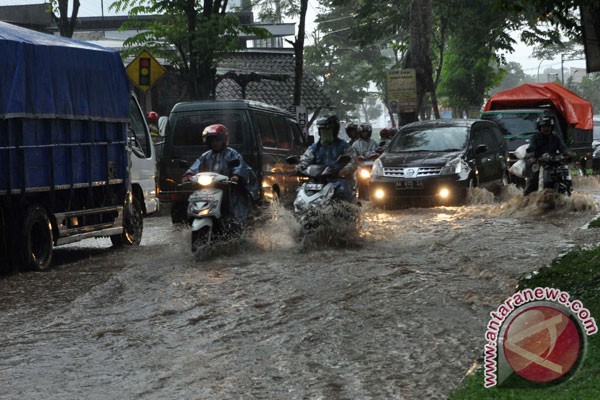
[216,49,331,110]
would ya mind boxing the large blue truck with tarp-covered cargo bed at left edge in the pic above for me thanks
[0,22,152,270]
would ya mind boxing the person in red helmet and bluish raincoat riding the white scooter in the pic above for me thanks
[182,124,257,225]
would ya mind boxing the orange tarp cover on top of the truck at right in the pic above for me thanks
[483,82,593,130]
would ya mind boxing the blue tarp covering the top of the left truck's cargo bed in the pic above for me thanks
[0,22,129,121]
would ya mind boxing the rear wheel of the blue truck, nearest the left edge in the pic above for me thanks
[16,206,54,271]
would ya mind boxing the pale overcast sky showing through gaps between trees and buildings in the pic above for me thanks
[5,0,585,76]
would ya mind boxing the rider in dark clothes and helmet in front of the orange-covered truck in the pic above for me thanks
[523,115,570,196]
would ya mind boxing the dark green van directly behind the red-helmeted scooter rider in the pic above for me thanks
[159,100,307,222]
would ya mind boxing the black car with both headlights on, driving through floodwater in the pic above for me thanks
[369,119,507,206]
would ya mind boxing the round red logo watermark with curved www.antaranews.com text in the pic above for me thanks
[484,287,598,388]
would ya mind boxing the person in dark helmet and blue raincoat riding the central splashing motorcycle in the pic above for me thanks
[296,115,357,202]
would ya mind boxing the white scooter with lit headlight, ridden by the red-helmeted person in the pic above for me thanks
[180,160,244,257]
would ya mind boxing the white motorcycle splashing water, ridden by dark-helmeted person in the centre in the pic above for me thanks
[286,156,358,236]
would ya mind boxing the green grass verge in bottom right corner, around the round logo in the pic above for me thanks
[449,245,600,400]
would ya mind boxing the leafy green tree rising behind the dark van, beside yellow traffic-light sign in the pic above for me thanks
[110,0,268,100]
